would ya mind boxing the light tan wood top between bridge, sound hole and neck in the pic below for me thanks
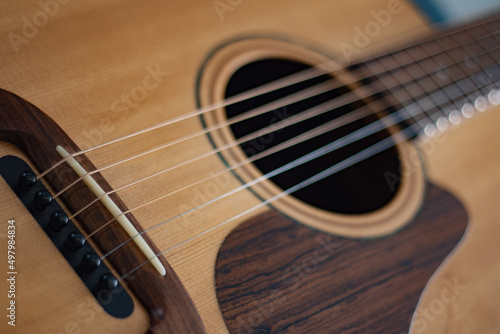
[0,0,427,333]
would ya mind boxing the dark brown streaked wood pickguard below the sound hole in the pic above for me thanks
[215,184,468,334]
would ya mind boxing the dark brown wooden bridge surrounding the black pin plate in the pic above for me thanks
[0,90,205,333]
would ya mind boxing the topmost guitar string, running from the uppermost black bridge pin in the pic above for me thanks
[37,17,497,179]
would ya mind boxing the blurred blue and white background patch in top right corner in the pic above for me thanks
[410,0,500,26]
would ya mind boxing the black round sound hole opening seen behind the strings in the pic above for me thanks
[226,59,400,214]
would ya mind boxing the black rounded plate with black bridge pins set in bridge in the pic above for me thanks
[0,156,134,318]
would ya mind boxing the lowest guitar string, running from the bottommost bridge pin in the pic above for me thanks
[119,75,500,281]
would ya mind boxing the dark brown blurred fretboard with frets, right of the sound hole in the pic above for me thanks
[361,16,500,135]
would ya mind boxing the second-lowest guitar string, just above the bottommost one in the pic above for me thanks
[102,68,500,258]
